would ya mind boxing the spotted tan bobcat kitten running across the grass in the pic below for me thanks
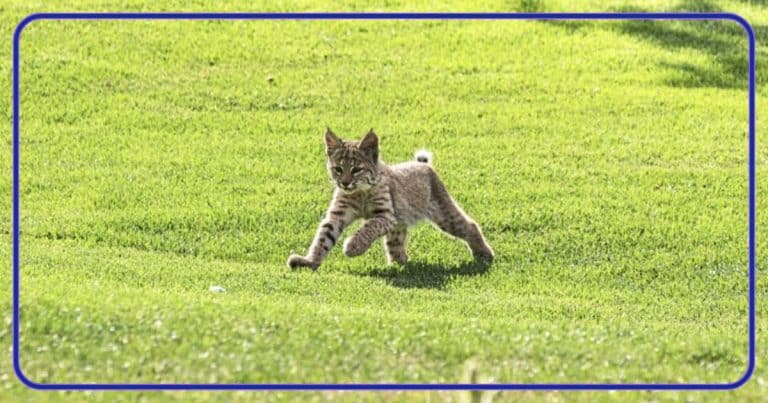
[288,129,493,270]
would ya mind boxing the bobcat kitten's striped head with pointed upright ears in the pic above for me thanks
[325,129,379,193]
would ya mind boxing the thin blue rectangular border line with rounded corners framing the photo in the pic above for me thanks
[11,12,756,390]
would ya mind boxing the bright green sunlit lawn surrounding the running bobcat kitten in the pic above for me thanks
[0,1,768,401]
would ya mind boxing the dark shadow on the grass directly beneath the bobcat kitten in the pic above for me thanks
[357,261,492,289]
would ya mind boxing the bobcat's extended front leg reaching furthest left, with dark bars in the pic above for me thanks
[288,197,358,270]
